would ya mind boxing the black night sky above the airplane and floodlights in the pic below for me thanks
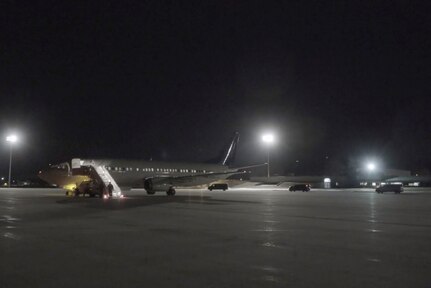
[0,0,431,174]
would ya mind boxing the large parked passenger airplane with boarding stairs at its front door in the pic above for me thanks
[39,133,265,196]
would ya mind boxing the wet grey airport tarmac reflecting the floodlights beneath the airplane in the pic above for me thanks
[0,186,431,288]
